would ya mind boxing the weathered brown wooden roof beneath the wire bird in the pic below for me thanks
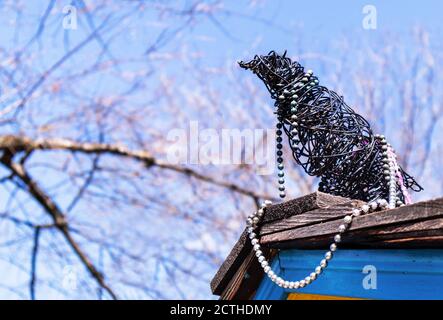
[211,192,443,299]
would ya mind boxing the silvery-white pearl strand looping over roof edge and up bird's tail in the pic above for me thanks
[247,135,406,289]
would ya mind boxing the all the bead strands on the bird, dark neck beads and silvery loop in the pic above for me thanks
[247,74,410,289]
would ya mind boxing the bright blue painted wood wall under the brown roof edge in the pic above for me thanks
[256,249,443,299]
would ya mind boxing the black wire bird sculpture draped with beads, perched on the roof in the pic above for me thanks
[239,51,423,206]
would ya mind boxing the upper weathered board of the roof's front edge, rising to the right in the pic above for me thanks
[260,198,443,247]
